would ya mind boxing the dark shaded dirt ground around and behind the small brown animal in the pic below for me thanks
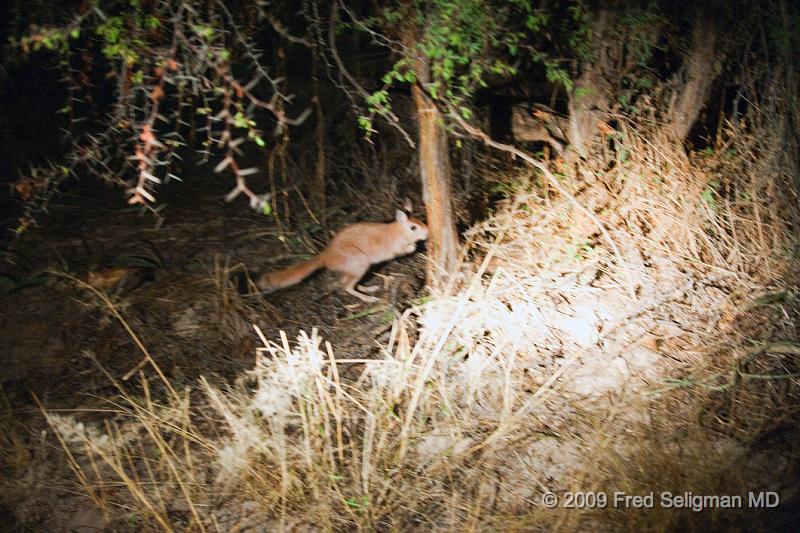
[0,170,432,530]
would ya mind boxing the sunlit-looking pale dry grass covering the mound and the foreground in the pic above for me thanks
[21,114,800,531]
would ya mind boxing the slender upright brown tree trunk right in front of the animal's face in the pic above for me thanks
[412,58,458,287]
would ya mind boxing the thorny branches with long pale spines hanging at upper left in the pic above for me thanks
[16,0,312,229]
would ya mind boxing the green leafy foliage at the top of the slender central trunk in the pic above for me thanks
[356,0,572,131]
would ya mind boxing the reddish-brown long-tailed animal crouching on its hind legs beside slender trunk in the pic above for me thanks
[256,211,428,302]
